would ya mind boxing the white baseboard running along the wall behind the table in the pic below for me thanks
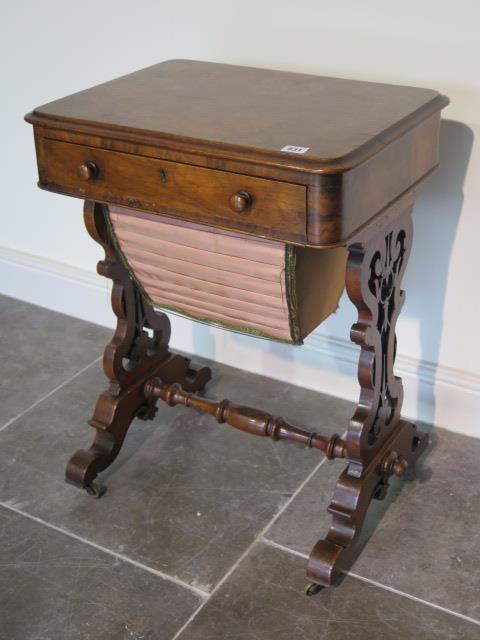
[0,247,480,437]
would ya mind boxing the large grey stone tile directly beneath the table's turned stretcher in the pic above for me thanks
[0,356,351,591]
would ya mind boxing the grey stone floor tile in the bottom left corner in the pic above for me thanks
[0,507,202,640]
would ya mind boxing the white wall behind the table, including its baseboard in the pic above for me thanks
[0,0,480,436]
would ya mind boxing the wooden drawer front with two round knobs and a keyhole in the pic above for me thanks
[39,139,306,242]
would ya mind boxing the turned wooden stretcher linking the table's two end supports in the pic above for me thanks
[144,378,347,460]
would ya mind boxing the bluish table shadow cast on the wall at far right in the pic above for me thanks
[403,120,474,423]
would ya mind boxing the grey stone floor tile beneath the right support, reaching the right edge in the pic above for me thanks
[266,429,480,624]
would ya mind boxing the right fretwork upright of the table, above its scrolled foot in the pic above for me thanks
[346,211,412,475]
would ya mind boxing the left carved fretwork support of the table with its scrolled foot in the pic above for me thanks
[66,201,211,495]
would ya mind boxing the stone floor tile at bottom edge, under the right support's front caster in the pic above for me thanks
[179,544,480,640]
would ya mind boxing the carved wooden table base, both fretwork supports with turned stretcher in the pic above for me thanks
[66,202,428,593]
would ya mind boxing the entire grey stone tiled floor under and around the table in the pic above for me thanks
[0,297,480,640]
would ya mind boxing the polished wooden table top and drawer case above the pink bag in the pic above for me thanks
[27,60,448,247]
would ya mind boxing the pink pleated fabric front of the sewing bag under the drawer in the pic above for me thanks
[109,206,292,341]
